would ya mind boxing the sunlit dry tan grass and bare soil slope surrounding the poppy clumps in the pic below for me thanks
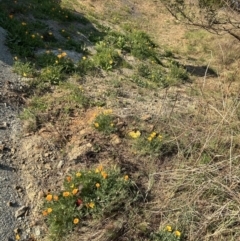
[1,1,240,241]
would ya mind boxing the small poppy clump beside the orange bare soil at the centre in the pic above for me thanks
[93,110,117,135]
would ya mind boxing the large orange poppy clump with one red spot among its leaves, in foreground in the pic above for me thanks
[43,165,137,240]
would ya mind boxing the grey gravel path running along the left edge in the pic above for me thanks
[0,28,22,241]
